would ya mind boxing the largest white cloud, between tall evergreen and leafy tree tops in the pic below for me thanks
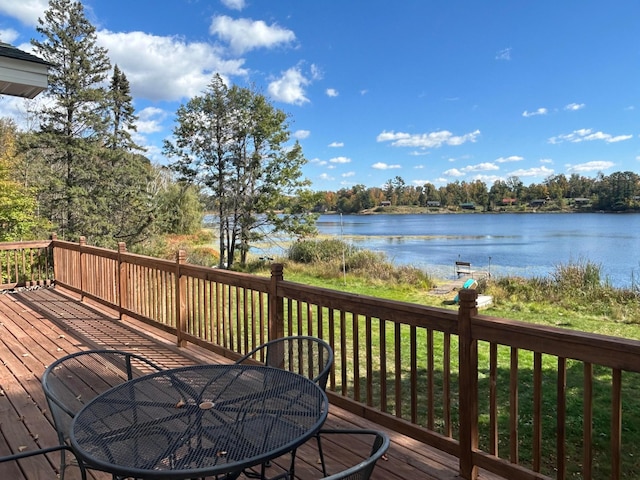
[98,30,247,101]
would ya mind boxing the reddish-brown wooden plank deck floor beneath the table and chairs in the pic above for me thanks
[0,288,480,480]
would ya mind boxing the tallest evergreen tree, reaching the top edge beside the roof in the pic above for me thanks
[32,0,111,238]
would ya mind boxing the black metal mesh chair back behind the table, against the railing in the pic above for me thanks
[236,335,333,390]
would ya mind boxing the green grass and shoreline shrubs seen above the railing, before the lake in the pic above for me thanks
[161,230,640,340]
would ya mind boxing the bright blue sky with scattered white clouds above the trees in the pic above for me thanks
[0,0,640,190]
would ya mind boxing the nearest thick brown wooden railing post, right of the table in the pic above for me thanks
[458,288,478,480]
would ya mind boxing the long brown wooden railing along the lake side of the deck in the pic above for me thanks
[5,238,640,480]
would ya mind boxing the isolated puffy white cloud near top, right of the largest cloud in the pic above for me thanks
[209,15,296,54]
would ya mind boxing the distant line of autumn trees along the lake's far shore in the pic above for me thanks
[317,172,640,213]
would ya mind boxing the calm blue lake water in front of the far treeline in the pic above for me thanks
[318,213,640,287]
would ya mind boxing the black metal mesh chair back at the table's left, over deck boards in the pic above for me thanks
[42,350,161,444]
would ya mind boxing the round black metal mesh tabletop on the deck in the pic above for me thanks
[71,364,328,479]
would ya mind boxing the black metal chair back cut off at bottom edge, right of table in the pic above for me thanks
[317,429,389,480]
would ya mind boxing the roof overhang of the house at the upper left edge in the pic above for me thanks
[0,43,49,98]
